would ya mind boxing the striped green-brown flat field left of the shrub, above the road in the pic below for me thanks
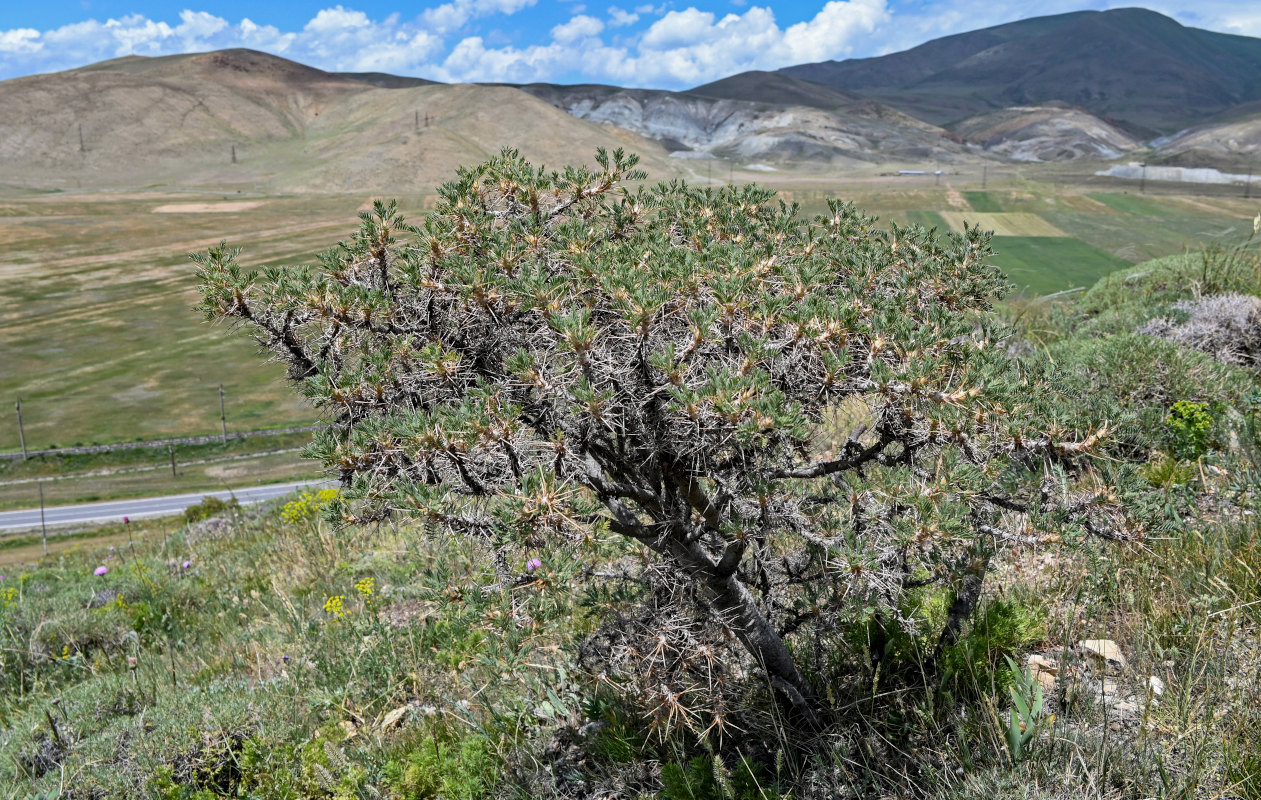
[0,193,383,450]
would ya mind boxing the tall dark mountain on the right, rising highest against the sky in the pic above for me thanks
[781,9,1261,138]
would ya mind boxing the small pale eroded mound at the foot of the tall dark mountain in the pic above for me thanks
[951,106,1142,162]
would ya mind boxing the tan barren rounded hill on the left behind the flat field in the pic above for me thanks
[0,50,672,192]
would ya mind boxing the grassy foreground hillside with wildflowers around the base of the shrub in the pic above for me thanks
[7,234,1261,800]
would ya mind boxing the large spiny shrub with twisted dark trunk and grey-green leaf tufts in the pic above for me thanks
[197,151,1131,736]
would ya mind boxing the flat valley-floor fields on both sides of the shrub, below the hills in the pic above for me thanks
[0,168,1261,469]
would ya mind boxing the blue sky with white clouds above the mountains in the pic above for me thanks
[0,0,1261,88]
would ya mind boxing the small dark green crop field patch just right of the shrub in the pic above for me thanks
[994,236,1129,294]
